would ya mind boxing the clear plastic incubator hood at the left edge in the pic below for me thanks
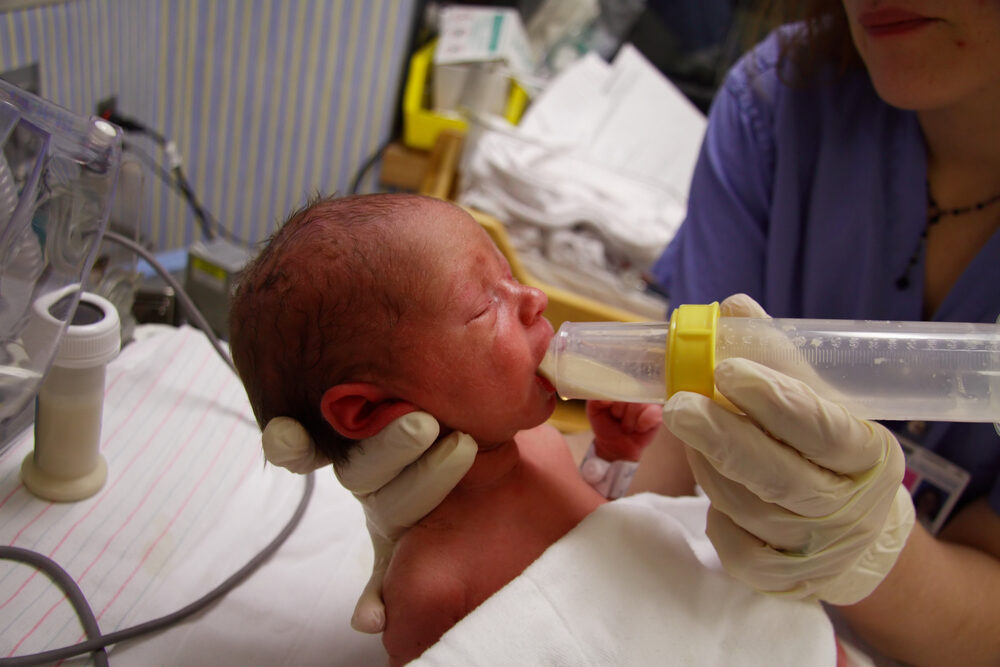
[0,80,122,438]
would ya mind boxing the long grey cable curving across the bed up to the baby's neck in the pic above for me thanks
[0,473,316,667]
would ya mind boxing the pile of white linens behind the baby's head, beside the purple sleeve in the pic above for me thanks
[458,44,706,271]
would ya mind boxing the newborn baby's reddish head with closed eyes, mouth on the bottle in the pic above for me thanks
[230,194,555,461]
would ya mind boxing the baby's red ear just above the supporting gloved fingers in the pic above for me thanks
[320,382,418,440]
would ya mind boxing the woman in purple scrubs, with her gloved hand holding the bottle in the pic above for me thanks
[326,0,1000,664]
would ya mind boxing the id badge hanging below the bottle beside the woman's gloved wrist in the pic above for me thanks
[896,433,971,535]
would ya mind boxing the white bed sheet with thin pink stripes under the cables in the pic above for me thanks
[0,326,386,666]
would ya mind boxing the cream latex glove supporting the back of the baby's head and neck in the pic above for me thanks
[263,412,479,633]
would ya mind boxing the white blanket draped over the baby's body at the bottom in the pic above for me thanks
[411,494,837,666]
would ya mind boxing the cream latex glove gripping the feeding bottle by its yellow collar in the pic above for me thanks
[663,295,913,605]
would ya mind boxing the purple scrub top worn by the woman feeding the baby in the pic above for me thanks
[653,27,1000,513]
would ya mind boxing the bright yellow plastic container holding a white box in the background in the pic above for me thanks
[403,41,528,150]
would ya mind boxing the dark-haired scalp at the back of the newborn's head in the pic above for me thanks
[229,195,424,460]
